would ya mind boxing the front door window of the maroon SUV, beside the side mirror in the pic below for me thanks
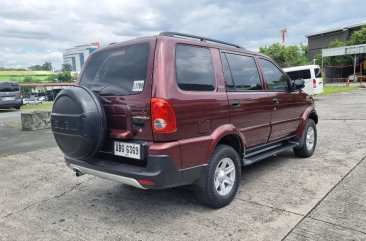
[259,59,289,91]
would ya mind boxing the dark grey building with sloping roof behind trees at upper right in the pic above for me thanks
[306,23,366,59]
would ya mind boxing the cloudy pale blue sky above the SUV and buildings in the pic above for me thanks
[0,0,366,69]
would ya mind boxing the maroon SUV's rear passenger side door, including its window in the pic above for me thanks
[221,52,272,148]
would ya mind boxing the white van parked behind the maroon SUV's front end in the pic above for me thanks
[283,65,324,95]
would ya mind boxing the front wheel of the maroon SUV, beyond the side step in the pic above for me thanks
[294,119,317,158]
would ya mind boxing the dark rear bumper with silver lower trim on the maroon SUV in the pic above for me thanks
[65,155,206,189]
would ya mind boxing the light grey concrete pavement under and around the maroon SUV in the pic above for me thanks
[0,89,366,240]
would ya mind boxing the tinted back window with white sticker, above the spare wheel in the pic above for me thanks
[80,43,150,96]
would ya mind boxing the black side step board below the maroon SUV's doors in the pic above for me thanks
[242,141,299,166]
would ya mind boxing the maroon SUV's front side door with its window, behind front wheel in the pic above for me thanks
[259,58,303,141]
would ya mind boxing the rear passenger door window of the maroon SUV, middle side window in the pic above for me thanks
[223,53,262,90]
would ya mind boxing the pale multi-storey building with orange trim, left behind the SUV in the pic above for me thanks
[63,42,99,73]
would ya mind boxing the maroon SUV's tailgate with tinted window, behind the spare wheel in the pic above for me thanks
[79,38,156,141]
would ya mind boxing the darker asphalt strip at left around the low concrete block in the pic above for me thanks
[0,110,56,157]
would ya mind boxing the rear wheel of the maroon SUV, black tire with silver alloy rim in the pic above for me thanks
[196,145,241,208]
